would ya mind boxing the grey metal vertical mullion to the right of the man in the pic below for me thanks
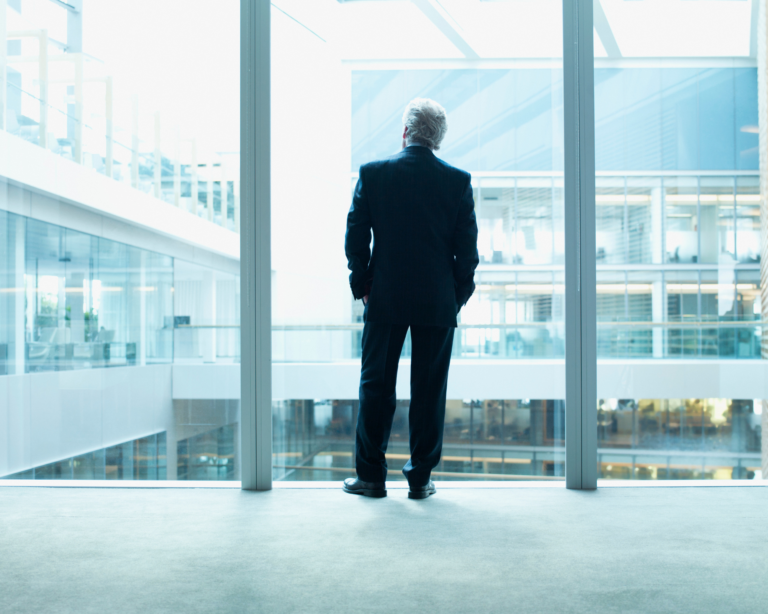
[563,0,597,489]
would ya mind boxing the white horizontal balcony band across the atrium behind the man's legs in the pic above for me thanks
[173,360,768,399]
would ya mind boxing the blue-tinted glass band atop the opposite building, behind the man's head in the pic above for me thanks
[352,68,758,171]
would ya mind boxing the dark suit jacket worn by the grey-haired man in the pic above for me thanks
[345,145,480,327]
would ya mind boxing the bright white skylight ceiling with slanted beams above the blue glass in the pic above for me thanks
[273,0,758,60]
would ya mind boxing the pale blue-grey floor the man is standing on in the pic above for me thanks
[0,487,768,614]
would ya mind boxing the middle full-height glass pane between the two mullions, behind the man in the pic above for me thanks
[272,0,564,480]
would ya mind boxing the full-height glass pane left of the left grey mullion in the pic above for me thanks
[0,0,240,480]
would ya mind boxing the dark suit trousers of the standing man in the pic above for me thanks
[355,322,455,486]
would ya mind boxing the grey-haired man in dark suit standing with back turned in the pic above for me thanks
[344,98,479,499]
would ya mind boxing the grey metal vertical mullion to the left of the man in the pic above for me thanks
[240,0,272,490]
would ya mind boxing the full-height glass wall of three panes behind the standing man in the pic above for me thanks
[0,0,763,488]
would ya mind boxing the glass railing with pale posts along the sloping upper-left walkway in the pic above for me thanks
[0,30,240,233]
